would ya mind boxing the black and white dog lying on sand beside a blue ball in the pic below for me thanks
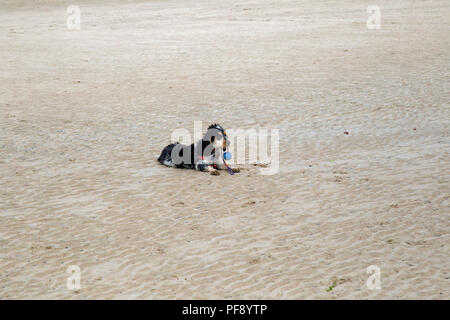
[158,124,239,175]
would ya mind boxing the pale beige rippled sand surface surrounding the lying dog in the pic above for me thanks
[0,0,450,299]
